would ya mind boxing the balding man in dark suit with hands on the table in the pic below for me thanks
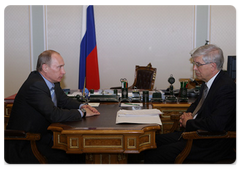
[4,50,100,164]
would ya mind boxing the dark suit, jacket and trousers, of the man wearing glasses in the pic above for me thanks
[145,71,237,164]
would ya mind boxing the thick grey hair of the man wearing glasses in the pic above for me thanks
[191,44,224,70]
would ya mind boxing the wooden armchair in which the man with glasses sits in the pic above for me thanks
[170,114,237,165]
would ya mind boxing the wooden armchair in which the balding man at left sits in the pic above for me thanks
[2,130,47,165]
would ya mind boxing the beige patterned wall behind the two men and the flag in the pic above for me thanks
[2,3,237,98]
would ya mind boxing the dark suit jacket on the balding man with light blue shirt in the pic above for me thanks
[7,71,82,162]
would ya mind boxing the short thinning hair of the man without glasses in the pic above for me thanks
[36,50,60,71]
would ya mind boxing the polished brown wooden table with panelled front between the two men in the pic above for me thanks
[48,104,160,165]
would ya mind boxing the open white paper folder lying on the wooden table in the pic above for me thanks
[116,109,162,125]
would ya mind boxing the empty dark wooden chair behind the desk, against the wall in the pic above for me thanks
[110,63,157,91]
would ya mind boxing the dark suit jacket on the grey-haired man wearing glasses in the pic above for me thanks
[186,71,237,131]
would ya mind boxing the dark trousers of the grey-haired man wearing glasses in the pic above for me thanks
[144,132,237,165]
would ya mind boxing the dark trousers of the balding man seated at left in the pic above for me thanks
[2,141,85,165]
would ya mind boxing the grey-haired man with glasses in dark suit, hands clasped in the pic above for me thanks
[145,44,237,164]
